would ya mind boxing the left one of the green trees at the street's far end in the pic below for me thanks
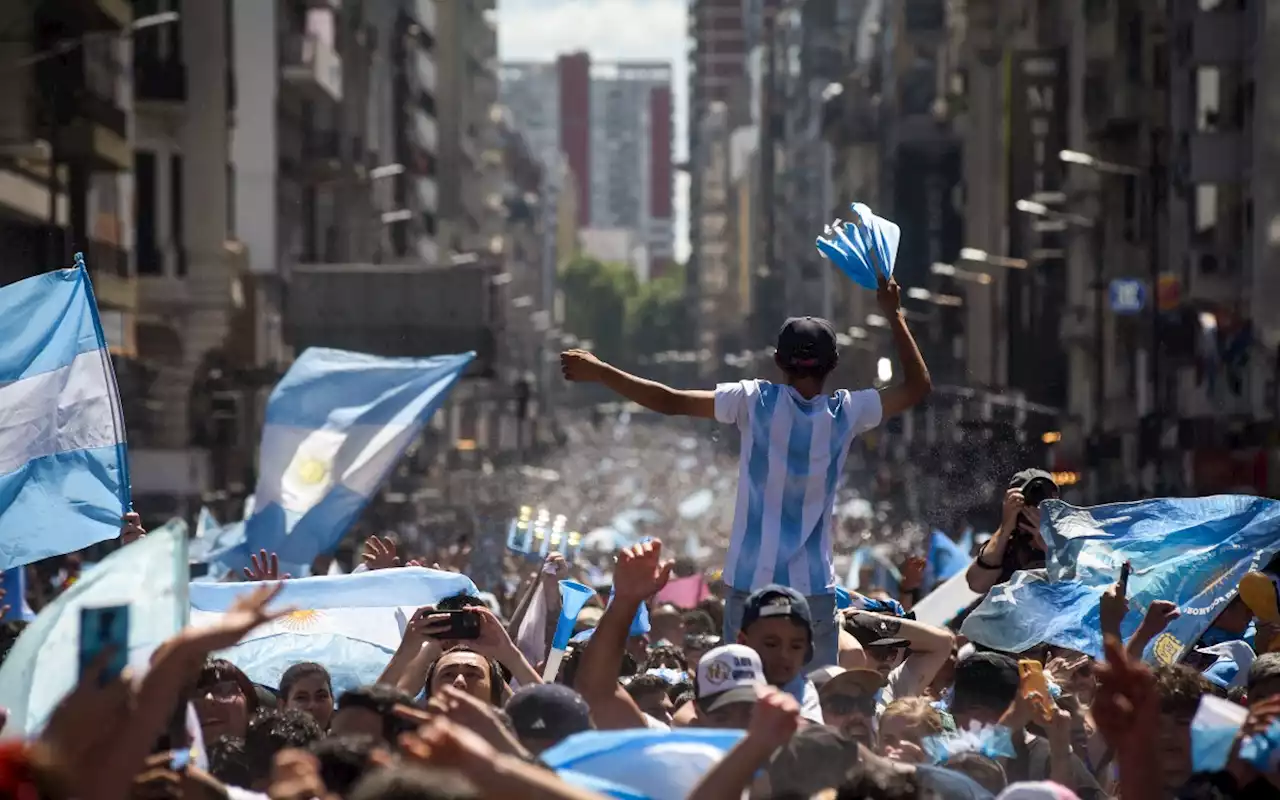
[559,257,639,360]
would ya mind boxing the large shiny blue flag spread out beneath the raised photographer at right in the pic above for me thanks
[960,495,1280,663]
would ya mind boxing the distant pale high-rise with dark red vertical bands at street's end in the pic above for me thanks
[502,52,675,274]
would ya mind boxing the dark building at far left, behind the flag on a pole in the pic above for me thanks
[0,0,137,348]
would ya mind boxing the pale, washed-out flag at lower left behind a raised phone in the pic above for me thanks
[0,527,188,735]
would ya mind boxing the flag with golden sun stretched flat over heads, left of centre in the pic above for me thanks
[191,567,476,692]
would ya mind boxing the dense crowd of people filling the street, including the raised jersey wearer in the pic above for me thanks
[0,280,1280,800]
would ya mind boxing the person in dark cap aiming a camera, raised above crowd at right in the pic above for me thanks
[965,470,1061,594]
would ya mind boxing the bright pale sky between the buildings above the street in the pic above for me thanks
[498,0,689,261]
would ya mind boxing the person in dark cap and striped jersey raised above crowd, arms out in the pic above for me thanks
[561,273,932,669]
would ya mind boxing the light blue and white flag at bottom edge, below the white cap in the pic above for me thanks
[543,728,742,800]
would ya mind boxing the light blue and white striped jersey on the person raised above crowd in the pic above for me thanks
[716,380,883,595]
